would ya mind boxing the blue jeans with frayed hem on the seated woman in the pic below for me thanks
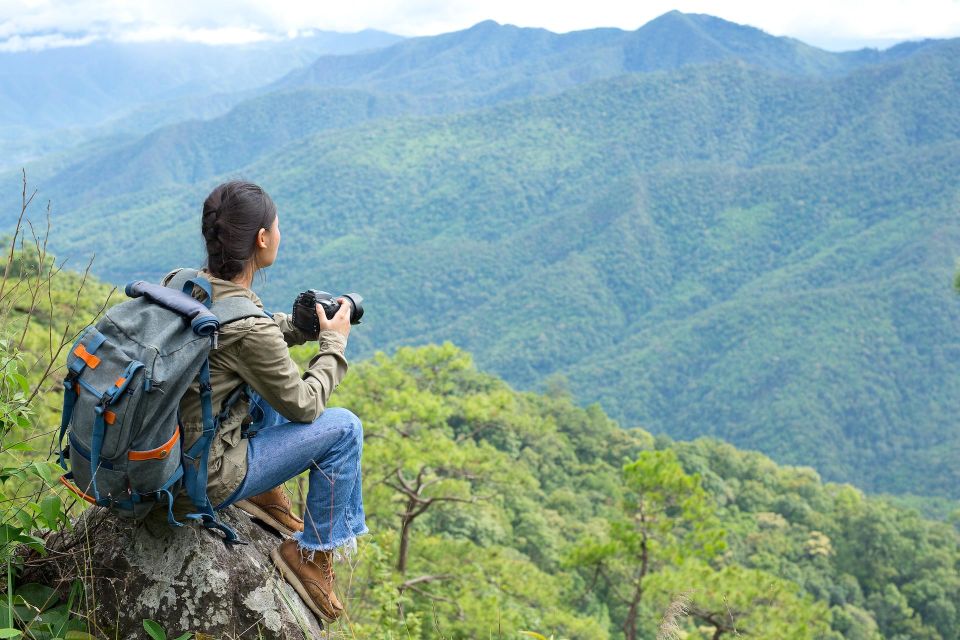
[216,394,368,556]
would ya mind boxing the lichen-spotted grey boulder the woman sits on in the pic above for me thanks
[25,507,327,640]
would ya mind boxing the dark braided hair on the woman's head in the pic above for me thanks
[202,180,277,280]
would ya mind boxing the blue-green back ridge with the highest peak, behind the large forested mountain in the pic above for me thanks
[26,11,943,202]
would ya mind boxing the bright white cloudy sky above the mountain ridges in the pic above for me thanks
[0,0,960,51]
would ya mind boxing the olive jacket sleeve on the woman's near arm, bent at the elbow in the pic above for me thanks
[237,318,347,422]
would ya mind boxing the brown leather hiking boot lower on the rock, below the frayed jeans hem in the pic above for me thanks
[270,539,343,622]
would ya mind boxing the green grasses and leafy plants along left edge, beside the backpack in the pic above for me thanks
[0,184,110,640]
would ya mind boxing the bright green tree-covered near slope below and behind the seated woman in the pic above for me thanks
[0,248,960,640]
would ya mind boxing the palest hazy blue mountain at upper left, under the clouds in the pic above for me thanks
[0,30,402,166]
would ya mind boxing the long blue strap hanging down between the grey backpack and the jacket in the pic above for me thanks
[183,360,245,545]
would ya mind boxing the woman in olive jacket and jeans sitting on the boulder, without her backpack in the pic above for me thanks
[165,181,367,622]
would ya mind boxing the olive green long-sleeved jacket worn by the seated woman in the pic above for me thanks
[163,270,347,506]
